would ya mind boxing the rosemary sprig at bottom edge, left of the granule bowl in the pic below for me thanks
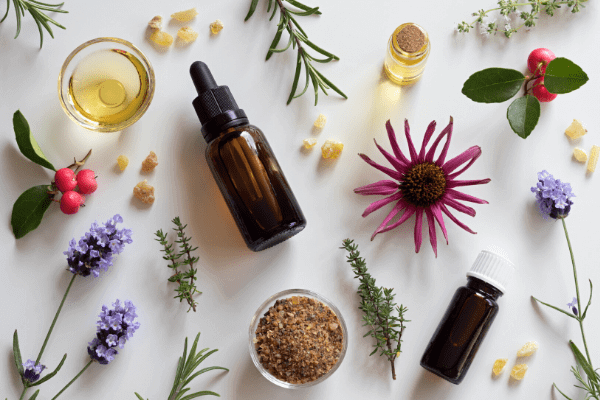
[135,333,229,400]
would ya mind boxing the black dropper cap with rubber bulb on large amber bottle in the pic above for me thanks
[190,61,249,142]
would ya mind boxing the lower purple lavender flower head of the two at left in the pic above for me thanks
[88,299,140,364]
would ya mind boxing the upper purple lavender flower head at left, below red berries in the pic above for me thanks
[63,214,132,277]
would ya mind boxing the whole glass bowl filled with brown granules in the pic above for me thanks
[249,289,348,389]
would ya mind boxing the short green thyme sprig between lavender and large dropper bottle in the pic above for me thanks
[155,217,202,312]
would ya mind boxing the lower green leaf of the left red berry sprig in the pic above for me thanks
[10,185,52,239]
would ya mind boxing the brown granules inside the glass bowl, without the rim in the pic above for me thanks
[254,296,344,384]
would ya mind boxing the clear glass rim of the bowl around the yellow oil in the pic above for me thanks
[58,37,155,132]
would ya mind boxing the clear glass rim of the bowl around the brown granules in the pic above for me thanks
[248,289,348,389]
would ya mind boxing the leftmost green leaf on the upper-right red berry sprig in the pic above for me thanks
[462,68,525,103]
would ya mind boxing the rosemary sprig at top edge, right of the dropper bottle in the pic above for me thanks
[245,0,348,105]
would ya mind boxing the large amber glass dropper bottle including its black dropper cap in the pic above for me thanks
[190,61,306,251]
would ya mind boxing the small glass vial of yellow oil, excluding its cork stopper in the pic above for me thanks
[384,23,431,85]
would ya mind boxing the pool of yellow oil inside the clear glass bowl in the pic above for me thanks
[69,49,148,126]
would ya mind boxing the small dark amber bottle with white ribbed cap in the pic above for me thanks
[421,248,514,385]
